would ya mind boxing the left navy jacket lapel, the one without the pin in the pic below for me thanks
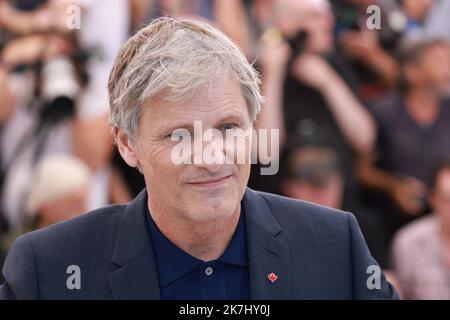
[108,189,160,299]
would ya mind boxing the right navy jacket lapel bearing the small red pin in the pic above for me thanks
[243,188,291,300]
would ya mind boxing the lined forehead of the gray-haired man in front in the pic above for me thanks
[141,79,250,129]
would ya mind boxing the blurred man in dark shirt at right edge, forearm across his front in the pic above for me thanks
[358,40,450,244]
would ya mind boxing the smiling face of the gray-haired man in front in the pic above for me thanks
[136,80,251,222]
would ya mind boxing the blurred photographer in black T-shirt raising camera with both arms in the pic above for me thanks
[258,0,375,208]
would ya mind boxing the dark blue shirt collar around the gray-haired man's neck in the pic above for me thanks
[145,206,248,287]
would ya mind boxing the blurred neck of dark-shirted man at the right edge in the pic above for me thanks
[406,89,441,126]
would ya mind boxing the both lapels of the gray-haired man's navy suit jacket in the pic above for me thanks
[108,188,291,300]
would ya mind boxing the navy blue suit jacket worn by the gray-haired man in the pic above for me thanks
[0,188,397,299]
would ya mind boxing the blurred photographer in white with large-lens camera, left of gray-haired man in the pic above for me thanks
[0,0,129,229]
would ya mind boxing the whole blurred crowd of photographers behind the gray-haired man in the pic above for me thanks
[0,0,450,299]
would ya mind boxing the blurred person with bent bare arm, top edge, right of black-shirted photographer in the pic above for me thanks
[333,0,399,101]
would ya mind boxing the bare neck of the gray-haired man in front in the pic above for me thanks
[149,203,241,261]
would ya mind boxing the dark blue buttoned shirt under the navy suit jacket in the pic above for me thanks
[146,208,250,300]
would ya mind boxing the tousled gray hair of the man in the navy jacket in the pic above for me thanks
[108,17,263,138]
